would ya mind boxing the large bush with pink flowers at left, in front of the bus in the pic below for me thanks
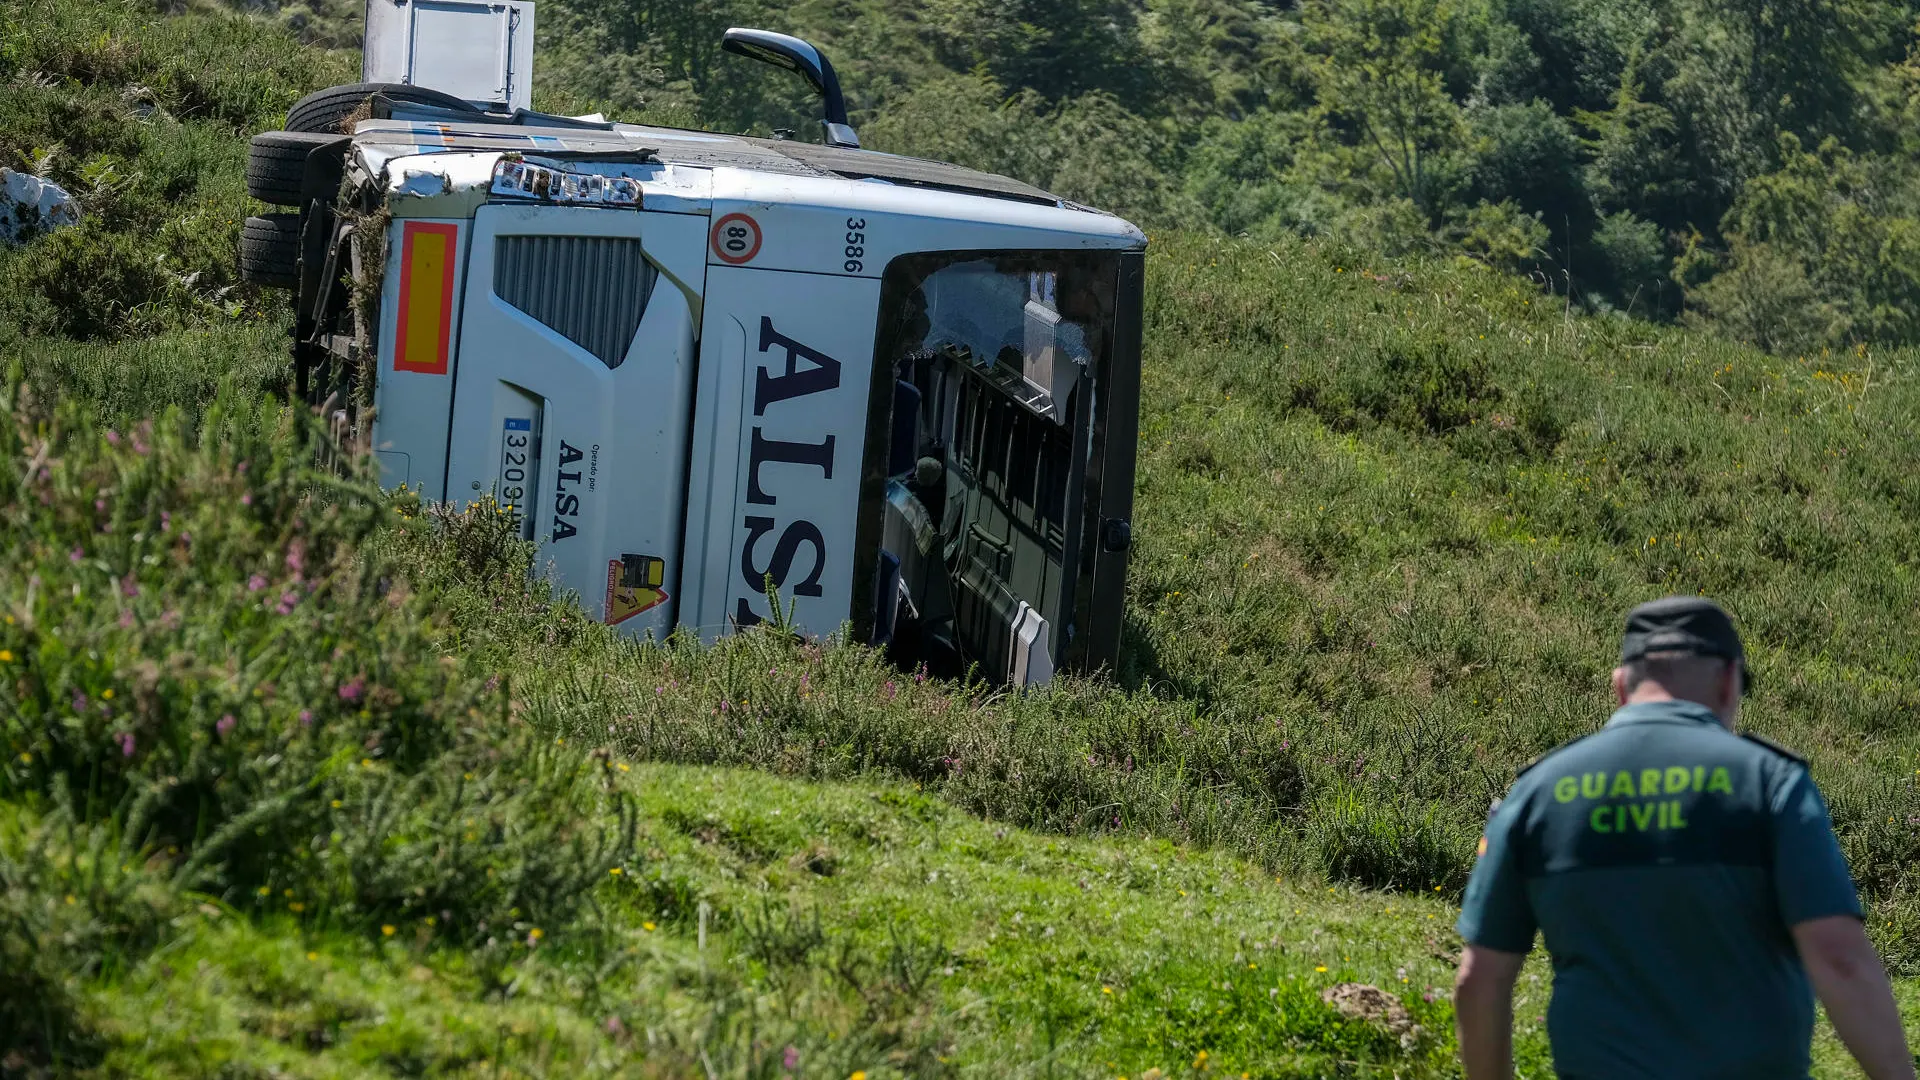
[0,375,620,957]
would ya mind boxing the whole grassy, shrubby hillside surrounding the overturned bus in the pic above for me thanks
[0,0,1920,1080]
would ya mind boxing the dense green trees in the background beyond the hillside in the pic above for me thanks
[247,0,1920,356]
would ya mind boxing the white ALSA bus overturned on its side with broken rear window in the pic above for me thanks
[240,0,1146,684]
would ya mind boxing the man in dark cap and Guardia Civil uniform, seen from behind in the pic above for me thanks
[1455,596,1914,1080]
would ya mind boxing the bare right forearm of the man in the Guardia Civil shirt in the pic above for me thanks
[1789,915,1914,1080]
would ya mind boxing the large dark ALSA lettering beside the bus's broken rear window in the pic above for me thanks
[733,315,841,626]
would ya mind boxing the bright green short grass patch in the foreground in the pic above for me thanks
[60,765,1474,1076]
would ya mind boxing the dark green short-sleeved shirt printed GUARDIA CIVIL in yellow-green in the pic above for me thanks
[1459,701,1860,1080]
